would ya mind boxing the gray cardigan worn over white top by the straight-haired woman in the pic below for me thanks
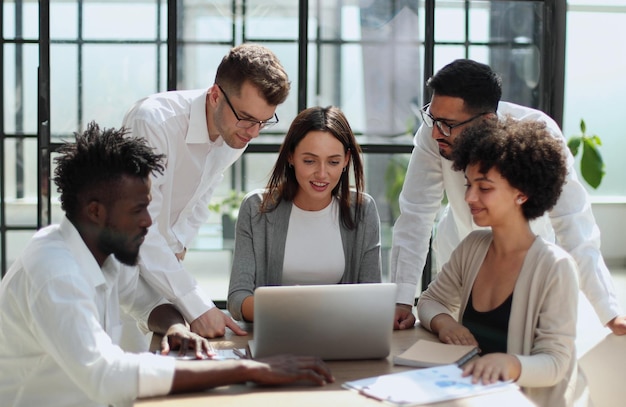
[228,190,382,320]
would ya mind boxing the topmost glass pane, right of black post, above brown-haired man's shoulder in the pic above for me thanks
[178,0,234,43]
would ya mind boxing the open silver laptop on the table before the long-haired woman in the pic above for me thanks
[248,283,396,360]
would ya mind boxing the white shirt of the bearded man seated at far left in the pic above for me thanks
[0,218,174,407]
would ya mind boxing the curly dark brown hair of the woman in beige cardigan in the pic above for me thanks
[452,117,567,220]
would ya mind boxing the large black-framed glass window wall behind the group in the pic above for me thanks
[0,0,564,300]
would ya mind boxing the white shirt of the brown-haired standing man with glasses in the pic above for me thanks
[123,89,244,322]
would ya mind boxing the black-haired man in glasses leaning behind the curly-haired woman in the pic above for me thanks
[391,59,626,335]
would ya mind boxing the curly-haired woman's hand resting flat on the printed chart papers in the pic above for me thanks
[456,353,522,384]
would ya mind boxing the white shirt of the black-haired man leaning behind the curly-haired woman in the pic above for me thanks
[391,102,622,324]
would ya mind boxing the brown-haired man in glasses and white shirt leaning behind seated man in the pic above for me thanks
[123,44,290,351]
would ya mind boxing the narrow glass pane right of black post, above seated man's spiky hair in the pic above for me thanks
[50,44,79,135]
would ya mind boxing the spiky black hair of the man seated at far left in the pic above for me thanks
[54,122,165,219]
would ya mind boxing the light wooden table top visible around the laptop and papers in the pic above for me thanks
[135,324,533,407]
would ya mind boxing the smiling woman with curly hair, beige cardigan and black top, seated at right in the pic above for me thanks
[417,117,578,407]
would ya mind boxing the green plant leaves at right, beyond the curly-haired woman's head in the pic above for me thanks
[567,119,605,189]
